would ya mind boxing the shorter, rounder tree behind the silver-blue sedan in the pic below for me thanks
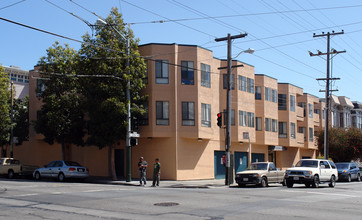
[35,42,85,159]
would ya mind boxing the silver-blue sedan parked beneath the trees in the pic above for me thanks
[33,160,89,182]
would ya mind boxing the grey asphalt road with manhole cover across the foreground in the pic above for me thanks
[0,179,362,220]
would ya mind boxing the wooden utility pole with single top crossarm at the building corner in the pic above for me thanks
[215,33,248,185]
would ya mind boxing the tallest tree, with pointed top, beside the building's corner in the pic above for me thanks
[80,8,147,179]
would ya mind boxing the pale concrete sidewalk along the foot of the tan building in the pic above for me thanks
[87,177,233,189]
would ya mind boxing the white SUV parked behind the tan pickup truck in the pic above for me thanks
[285,159,338,188]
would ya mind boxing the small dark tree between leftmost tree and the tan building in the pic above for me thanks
[13,96,29,145]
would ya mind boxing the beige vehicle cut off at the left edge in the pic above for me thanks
[0,157,38,179]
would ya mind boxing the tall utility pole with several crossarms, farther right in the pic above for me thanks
[309,30,346,159]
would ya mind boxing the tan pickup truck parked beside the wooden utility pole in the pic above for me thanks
[235,162,284,187]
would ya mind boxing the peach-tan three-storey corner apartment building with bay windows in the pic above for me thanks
[10,44,324,180]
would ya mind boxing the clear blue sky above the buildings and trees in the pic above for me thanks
[0,0,362,102]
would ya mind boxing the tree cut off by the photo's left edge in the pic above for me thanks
[0,66,10,156]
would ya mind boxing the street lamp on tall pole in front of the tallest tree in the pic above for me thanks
[96,19,132,182]
